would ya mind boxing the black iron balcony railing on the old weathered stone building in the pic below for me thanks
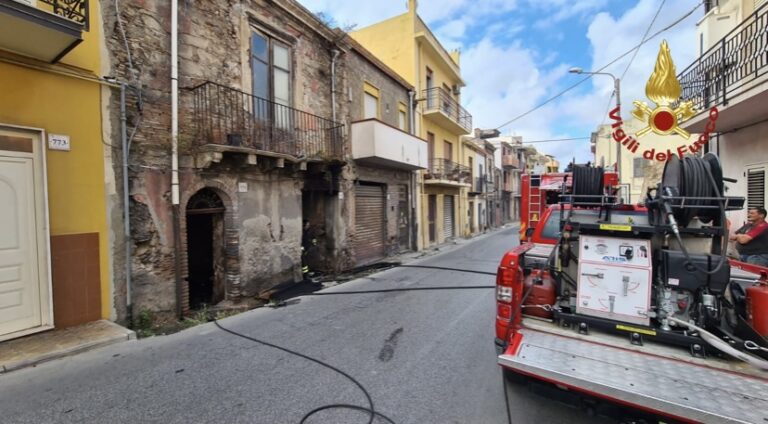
[192,81,344,160]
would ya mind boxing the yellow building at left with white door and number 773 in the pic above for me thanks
[0,0,112,341]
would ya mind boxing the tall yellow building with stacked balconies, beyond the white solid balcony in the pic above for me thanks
[350,0,472,247]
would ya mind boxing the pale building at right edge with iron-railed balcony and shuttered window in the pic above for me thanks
[678,0,768,229]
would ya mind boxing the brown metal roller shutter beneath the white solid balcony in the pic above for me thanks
[353,185,386,265]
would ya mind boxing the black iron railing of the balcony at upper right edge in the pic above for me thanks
[678,3,768,111]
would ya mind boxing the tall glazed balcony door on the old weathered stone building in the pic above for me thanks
[251,31,293,134]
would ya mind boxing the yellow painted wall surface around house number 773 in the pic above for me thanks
[0,1,111,318]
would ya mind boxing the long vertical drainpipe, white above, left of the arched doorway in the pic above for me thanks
[171,0,182,318]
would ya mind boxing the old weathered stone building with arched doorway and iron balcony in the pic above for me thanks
[102,0,350,318]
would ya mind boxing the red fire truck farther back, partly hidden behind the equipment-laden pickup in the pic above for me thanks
[520,172,619,243]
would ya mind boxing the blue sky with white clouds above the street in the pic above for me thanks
[299,0,704,163]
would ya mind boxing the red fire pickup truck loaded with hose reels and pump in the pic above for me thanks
[495,154,768,423]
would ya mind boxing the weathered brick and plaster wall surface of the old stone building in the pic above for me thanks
[102,0,342,320]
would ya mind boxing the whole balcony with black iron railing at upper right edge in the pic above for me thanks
[678,3,768,132]
